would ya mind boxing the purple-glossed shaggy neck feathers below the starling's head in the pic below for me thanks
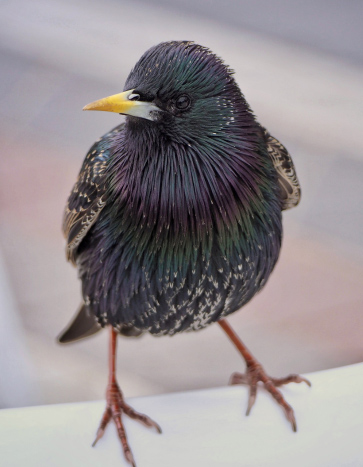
[107,119,278,252]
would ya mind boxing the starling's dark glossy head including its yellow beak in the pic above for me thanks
[84,41,250,143]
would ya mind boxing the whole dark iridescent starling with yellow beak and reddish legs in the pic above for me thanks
[59,41,310,466]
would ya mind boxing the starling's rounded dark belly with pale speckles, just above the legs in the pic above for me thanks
[80,227,280,335]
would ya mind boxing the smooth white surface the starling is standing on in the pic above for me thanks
[0,363,363,467]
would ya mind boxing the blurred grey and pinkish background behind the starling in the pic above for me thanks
[0,0,363,407]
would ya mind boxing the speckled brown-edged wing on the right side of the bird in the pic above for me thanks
[263,128,301,210]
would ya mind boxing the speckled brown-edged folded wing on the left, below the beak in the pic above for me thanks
[63,124,124,262]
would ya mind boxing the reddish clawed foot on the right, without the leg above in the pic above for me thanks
[229,361,311,431]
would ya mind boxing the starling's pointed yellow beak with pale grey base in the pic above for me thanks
[83,89,160,120]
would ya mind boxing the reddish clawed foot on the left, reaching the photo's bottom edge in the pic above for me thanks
[92,382,161,467]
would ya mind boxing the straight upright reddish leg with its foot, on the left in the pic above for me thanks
[92,326,161,467]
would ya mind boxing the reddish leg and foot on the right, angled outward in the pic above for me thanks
[218,319,311,431]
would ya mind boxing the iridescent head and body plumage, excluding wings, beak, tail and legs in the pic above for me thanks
[73,42,282,334]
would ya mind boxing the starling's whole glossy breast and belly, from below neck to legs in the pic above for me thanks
[79,141,281,334]
